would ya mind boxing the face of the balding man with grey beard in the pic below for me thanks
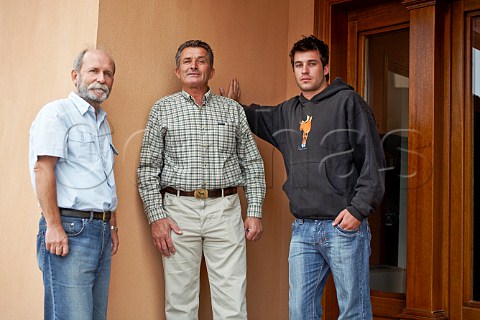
[72,50,115,107]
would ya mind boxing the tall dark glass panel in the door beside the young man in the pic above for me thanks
[363,29,409,293]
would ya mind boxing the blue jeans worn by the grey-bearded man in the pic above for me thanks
[37,217,112,320]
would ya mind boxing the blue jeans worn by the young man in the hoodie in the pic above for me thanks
[288,219,372,320]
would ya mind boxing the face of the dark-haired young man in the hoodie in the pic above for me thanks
[293,50,330,99]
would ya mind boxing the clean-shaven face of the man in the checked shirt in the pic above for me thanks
[175,47,215,91]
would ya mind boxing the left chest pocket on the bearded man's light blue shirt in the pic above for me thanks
[67,130,100,163]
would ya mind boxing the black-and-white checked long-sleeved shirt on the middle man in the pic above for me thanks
[138,91,265,223]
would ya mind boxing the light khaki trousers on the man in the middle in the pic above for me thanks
[163,193,247,320]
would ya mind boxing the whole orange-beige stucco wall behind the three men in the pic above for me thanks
[0,0,314,320]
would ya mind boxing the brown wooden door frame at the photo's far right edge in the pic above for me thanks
[449,0,480,320]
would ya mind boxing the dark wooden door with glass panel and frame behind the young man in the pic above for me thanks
[317,1,409,319]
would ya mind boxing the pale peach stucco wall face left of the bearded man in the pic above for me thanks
[0,0,98,320]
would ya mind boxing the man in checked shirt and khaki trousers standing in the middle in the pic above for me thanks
[138,40,265,320]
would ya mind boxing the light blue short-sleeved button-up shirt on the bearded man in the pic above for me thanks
[29,92,118,211]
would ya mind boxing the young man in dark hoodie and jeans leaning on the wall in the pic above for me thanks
[221,36,385,320]
